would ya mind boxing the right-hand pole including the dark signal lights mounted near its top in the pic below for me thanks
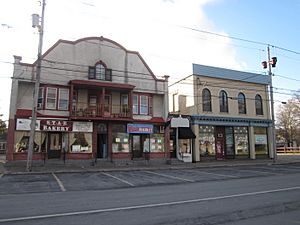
[262,45,277,162]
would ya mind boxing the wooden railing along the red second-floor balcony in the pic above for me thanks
[71,104,132,118]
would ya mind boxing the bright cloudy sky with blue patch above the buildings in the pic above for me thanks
[0,0,300,120]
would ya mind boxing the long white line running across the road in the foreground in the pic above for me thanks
[0,186,300,223]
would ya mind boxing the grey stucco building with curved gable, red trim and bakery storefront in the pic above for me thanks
[7,37,169,161]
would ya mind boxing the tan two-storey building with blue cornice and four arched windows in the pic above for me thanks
[169,64,274,162]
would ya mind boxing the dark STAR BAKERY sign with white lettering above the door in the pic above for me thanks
[40,120,72,132]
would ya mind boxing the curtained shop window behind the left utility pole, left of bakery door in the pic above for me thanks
[15,131,46,152]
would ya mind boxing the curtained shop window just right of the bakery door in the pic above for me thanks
[69,132,92,153]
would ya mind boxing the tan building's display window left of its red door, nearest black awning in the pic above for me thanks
[199,126,216,156]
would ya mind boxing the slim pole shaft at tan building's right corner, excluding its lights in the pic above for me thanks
[267,45,277,162]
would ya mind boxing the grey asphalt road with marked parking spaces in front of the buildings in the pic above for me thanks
[0,165,300,225]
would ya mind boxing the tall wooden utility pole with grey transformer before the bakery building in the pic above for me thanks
[26,0,46,172]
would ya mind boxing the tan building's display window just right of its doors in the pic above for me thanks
[234,127,249,156]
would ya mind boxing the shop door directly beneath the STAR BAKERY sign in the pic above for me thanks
[48,133,62,159]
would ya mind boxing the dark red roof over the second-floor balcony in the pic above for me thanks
[70,80,135,90]
